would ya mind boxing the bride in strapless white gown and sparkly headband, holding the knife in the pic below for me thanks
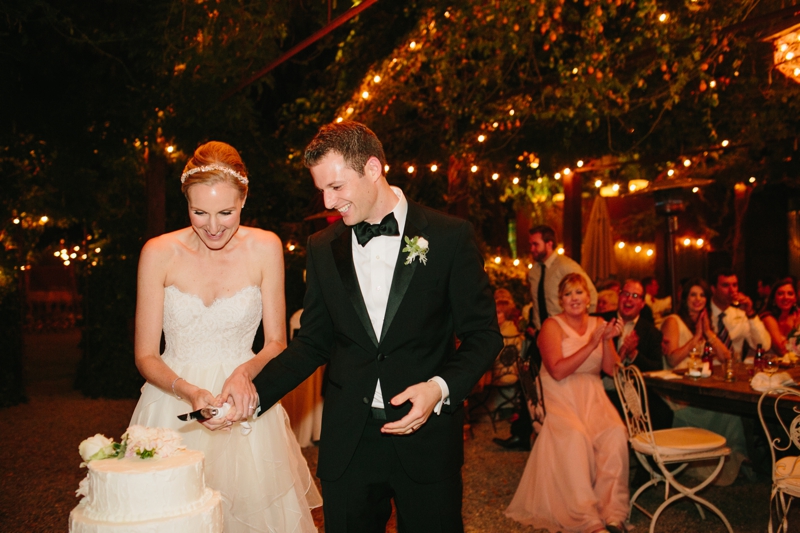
[131,142,322,533]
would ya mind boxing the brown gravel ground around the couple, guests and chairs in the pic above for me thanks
[0,332,800,533]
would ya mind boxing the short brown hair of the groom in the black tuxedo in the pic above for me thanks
[305,120,386,175]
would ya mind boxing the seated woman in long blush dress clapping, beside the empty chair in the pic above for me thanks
[506,273,629,533]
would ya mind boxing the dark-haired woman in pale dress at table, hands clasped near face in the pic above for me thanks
[661,279,747,486]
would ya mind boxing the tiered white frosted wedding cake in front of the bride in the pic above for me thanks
[69,450,222,533]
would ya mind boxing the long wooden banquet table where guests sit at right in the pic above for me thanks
[644,364,800,420]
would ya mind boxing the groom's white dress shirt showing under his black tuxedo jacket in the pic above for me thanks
[351,187,450,414]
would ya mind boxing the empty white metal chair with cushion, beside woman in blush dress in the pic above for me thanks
[614,365,733,533]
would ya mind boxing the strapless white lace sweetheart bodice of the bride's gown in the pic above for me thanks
[163,285,261,366]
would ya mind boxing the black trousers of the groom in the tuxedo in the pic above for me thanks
[322,415,464,533]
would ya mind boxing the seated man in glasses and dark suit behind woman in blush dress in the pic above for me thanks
[600,279,672,429]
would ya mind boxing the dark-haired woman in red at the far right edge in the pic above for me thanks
[761,277,800,355]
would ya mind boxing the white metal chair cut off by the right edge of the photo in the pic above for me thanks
[758,388,800,533]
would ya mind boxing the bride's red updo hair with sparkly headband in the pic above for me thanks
[181,141,248,200]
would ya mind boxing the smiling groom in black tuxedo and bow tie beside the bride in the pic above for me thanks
[253,122,502,533]
